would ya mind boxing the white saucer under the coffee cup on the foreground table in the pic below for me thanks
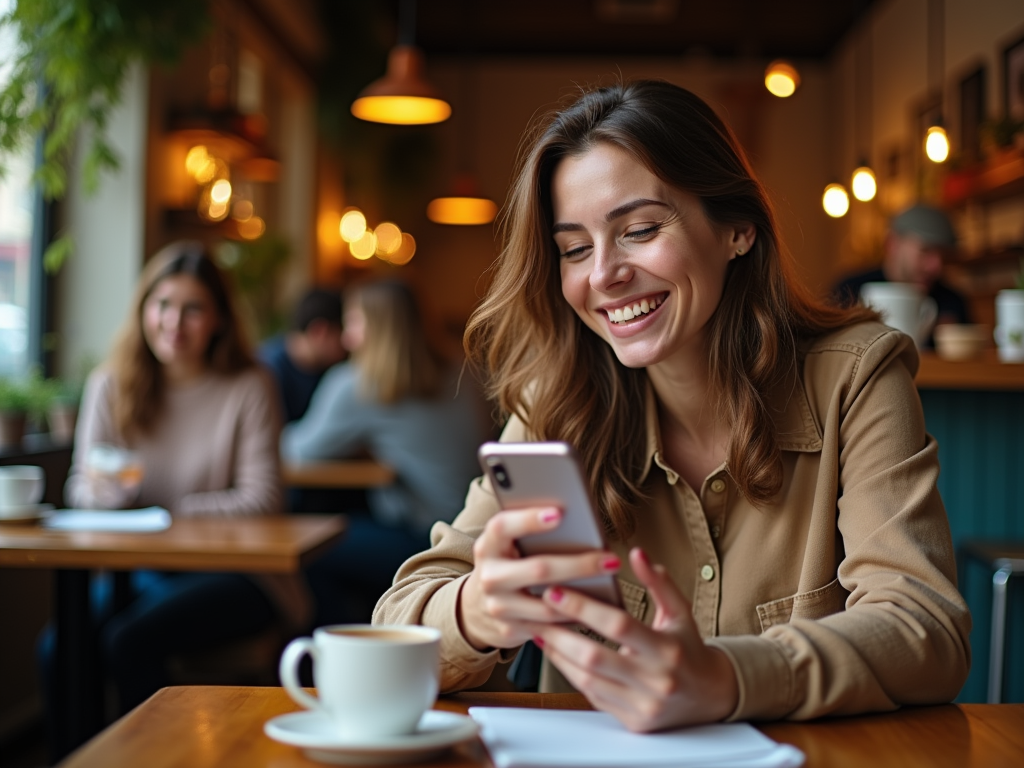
[263,710,477,765]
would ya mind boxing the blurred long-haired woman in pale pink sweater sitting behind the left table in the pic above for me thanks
[54,242,292,712]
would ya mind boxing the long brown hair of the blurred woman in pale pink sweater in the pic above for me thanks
[110,241,255,442]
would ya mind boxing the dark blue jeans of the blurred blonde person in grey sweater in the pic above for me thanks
[305,514,430,627]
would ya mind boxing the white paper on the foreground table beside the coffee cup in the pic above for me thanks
[469,707,804,768]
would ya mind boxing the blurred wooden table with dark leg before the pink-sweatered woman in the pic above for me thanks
[0,515,345,757]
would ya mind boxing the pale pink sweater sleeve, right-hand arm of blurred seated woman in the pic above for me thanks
[173,367,284,517]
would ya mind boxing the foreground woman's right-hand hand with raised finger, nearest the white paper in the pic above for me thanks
[535,549,739,731]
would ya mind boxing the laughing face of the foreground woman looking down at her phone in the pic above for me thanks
[551,143,753,368]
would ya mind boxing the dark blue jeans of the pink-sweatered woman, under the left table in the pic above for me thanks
[39,571,276,714]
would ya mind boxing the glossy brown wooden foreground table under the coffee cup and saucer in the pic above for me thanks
[61,686,1024,768]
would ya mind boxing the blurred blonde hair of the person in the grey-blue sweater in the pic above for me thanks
[345,280,442,404]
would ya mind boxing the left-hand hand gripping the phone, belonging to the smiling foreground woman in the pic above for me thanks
[459,507,621,650]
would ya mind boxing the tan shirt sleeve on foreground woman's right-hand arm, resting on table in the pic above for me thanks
[709,332,971,720]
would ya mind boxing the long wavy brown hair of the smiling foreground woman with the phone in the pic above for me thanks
[465,80,877,538]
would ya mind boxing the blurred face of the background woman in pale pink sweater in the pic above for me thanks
[142,274,220,370]
